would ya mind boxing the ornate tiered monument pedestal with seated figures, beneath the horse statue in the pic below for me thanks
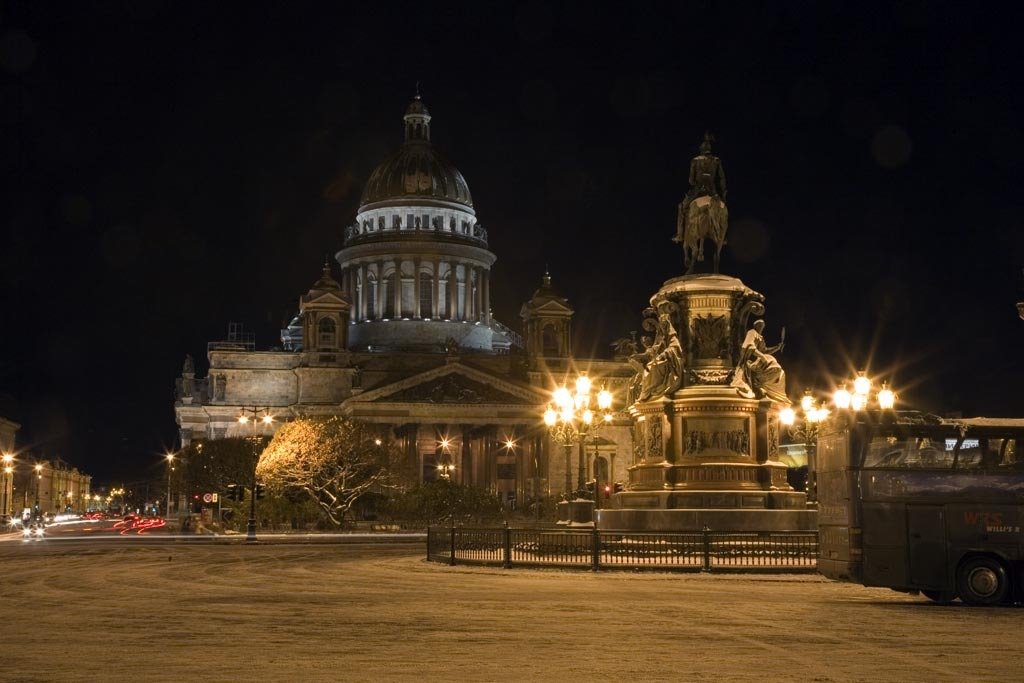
[595,274,817,531]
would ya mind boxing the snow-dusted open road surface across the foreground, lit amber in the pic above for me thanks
[0,538,1024,683]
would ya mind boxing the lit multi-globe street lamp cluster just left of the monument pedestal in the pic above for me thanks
[544,373,611,507]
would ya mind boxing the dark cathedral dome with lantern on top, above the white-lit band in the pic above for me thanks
[359,95,473,211]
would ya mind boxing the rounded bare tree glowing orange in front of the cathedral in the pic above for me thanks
[256,417,400,525]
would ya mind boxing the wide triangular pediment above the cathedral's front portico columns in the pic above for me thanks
[346,362,547,405]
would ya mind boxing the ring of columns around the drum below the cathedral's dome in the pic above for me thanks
[341,257,490,325]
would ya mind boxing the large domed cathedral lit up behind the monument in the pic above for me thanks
[175,96,634,506]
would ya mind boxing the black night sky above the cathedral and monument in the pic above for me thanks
[0,0,1024,482]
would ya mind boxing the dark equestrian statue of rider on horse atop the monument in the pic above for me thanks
[673,133,729,274]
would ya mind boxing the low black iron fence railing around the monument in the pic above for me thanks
[427,525,818,572]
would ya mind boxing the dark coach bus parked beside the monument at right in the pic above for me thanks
[816,411,1024,605]
